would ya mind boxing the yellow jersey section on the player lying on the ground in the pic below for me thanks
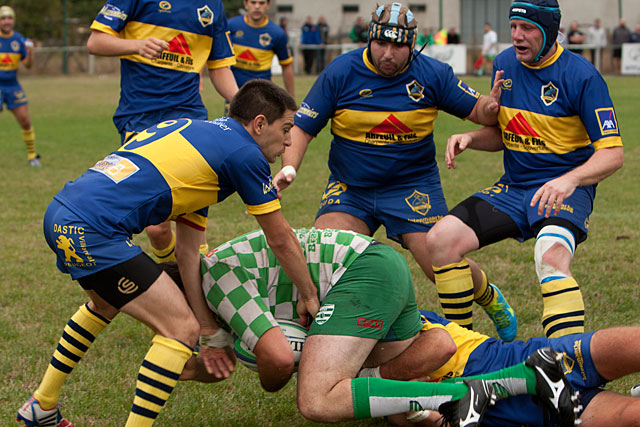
[422,317,489,380]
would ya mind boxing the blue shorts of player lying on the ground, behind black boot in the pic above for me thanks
[463,332,607,426]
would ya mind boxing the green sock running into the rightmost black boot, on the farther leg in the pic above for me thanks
[444,362,536,400]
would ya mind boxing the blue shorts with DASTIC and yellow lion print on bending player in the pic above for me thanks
[43,200,142,280]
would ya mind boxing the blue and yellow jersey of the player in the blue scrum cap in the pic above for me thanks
[494,45,622,185]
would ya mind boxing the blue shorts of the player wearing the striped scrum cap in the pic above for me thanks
[316,175,449,247]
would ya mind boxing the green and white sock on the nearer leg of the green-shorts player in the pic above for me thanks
[351,377,468,419]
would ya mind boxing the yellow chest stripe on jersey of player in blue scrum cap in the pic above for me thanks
[498,106,591,154]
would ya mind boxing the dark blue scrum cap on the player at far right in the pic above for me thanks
[509,0,561,62]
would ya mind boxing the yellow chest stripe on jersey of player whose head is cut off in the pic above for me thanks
[119,21,213,73]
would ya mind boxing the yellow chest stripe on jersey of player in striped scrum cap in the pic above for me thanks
[331,107,438,145]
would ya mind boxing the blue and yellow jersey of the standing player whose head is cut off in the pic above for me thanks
[91,0,235,117]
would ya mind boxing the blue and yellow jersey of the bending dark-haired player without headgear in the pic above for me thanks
[55,117,280,236]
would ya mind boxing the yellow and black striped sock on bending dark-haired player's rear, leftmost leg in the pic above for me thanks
[33,304,110,409]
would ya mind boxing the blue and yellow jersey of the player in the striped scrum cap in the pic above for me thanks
[295,48,479,187]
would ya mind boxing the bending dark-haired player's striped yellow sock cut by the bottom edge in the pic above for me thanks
[126,335,193,427]
